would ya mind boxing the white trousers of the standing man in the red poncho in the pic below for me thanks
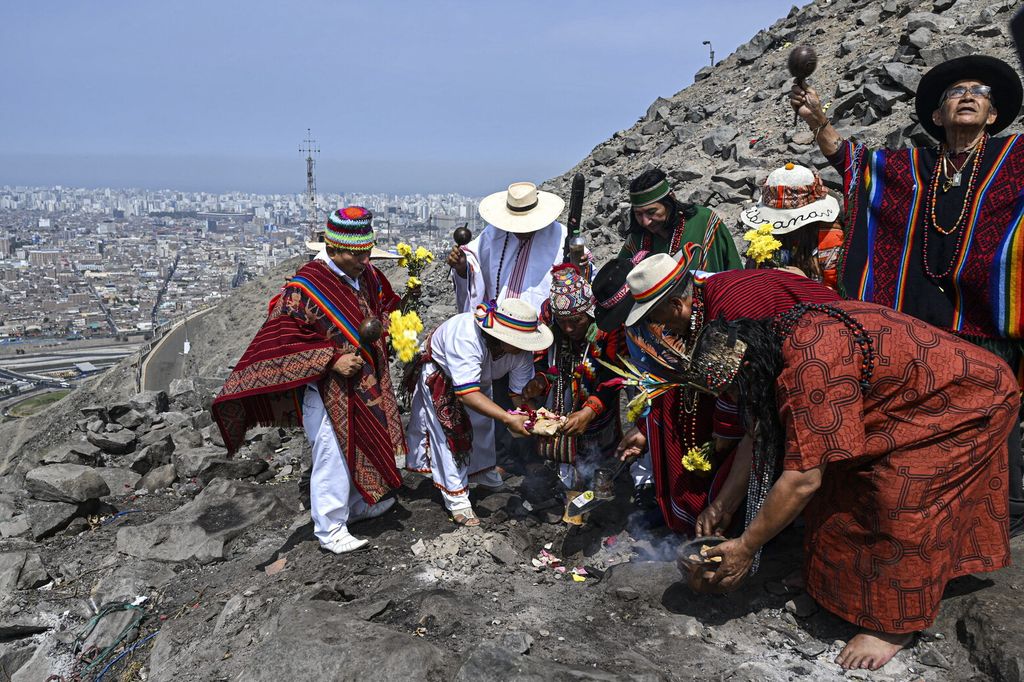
[302,384,369,543]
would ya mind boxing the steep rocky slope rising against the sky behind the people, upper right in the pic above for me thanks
[546,0,1024,249]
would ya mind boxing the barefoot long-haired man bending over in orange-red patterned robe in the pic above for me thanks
[687,301,1020,670]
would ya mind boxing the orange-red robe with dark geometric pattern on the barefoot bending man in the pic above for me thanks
[776,301,1020,634]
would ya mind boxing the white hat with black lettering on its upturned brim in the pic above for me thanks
[739,164,839,235]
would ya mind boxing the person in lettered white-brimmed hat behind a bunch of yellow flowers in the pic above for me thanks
[739,163,843,289]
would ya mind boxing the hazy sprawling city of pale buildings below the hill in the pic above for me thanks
[0,183,480,396]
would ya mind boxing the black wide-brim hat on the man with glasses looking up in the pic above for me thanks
[914,54,1024,141]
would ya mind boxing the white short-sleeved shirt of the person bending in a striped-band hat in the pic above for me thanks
[430,312,534,394]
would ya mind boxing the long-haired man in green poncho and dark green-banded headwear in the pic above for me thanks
[618,168,743,272]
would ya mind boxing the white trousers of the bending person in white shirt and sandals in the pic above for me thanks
[406,363,498,511]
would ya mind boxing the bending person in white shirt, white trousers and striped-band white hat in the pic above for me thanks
[406,299,552,526]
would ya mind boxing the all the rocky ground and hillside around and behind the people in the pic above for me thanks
[0,0,1024,682]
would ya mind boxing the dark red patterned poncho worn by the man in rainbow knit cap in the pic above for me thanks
[212,254,406,504]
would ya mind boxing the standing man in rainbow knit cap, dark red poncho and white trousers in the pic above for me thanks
[212,206,406,554]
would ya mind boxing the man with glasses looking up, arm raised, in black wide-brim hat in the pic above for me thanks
[790,55,1024,535]
